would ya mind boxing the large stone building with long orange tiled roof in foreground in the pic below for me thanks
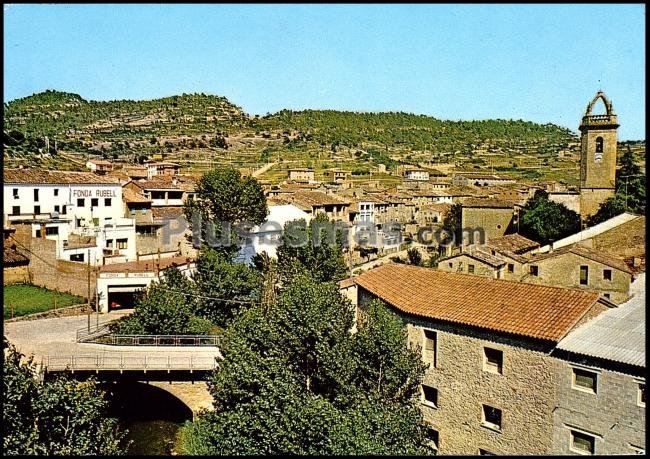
[354,264,612,455]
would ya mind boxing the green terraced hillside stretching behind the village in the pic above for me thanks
[4,91,645,183]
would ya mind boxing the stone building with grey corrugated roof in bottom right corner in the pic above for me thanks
[552,274,646,455]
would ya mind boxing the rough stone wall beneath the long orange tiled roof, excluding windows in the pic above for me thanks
[359,288,557,455]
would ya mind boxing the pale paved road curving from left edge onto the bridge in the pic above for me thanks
[4,311,220,372]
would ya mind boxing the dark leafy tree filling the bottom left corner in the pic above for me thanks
[2,338,127,455]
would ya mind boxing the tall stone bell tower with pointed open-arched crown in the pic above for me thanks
[580,91,619,218]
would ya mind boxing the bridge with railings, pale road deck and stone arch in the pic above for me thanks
[4,310,221,414]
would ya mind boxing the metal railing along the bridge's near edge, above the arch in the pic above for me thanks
[42,354,219,373]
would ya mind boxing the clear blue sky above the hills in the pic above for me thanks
[4,4,645,139]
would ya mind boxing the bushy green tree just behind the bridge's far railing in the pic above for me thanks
[110,268,212,335]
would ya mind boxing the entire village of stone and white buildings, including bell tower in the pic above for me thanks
[3,92,646,455]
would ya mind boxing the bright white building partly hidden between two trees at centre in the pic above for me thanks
[237,204,312,264]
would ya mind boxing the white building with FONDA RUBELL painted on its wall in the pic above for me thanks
[3,169,136,265]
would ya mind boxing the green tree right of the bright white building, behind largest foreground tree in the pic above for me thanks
[277,213,348,282]
